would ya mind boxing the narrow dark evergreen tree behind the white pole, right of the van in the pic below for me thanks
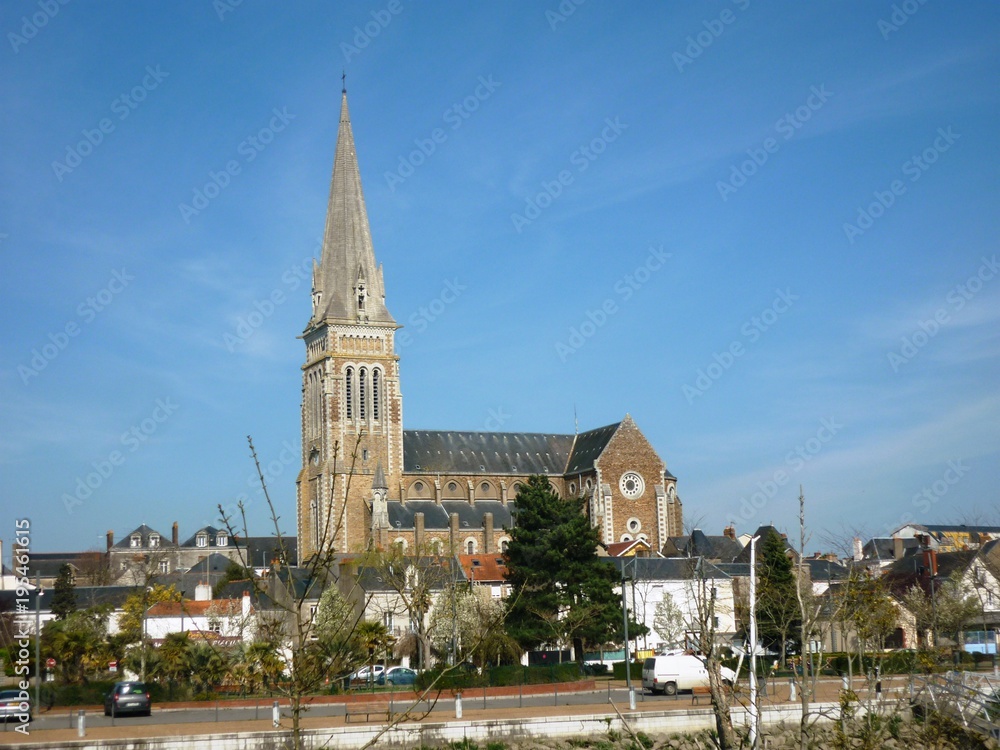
[757,529,802,662]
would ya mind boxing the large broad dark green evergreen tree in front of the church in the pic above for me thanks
[506,476,622,660]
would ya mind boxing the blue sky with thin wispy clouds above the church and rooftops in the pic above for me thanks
[0,0,1000,551]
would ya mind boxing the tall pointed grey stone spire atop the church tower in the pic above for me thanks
[310,90,398,328]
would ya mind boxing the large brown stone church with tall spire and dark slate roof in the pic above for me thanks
[296,90,683,560]
